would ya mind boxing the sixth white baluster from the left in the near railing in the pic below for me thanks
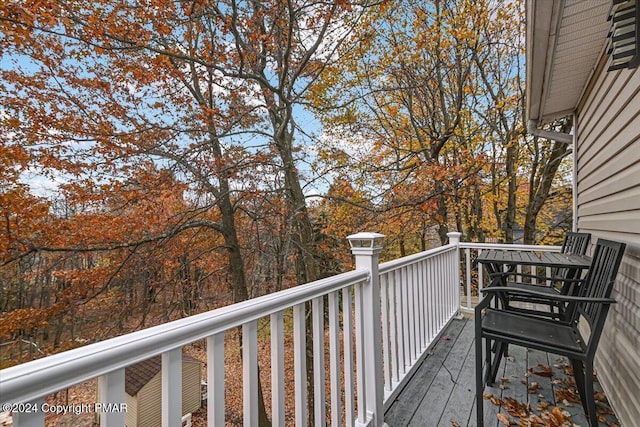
[270,311,285,426]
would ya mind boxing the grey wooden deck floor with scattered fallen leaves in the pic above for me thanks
[385,318,618,427]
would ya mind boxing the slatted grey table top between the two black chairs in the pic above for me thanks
[478,249,591,268]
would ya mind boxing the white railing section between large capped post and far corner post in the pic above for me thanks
[380,239,460,404]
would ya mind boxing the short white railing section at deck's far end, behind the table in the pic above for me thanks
[460,242,561,313]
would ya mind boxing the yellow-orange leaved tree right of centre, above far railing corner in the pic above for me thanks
[316,1,483,243]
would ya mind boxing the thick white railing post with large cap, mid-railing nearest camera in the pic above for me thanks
[347,233,384,427]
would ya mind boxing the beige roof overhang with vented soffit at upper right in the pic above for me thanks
[526,0,611,123]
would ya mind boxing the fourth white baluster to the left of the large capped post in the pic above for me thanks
[311,297,326,425]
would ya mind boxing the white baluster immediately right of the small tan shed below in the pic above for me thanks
[207,332,225,427]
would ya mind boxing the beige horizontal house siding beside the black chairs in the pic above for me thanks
[575,57,640,426]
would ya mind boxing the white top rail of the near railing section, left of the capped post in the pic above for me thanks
[0,269,369,408]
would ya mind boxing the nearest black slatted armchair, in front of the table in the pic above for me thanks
[475,239,625,427]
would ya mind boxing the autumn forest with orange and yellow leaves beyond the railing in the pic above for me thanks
[0,0,572,374]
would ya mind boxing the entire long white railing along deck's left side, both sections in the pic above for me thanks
[0,233,470,427]
